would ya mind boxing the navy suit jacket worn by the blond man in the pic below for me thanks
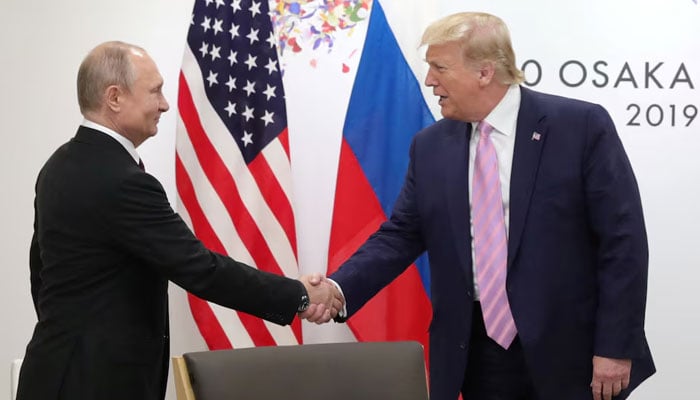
[331,88,655,400]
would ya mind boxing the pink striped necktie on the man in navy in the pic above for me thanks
[472,121,517,349]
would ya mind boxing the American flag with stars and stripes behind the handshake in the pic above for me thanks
[175,0,302,349]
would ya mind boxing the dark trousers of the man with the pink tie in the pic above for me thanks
[462,302,537,400]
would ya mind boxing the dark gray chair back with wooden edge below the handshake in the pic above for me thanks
[173,342,428,400]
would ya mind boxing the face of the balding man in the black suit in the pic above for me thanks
[117,53,169,146]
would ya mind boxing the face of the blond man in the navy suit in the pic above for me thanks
[425,42,483,122]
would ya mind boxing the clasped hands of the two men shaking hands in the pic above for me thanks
[299,273,345,324]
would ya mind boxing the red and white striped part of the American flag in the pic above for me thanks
[175,46,302,349]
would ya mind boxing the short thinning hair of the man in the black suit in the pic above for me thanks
[77,41,145,114]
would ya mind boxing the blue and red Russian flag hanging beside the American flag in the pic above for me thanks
[328,0,434,350]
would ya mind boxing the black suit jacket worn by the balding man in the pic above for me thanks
[18,127,303,400]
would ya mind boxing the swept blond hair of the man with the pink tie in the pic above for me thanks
[421,12,524,85]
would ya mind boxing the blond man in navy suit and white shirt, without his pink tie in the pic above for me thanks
[330,13,655,400]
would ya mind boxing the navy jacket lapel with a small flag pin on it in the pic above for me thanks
[508,87,547,268]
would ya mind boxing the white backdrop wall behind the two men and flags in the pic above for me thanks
[0,0,700,400]
